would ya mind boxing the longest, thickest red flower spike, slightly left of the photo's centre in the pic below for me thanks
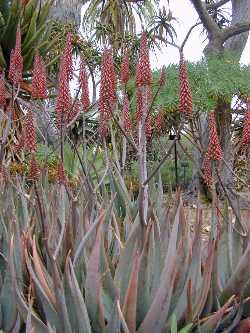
[98,49,116,137]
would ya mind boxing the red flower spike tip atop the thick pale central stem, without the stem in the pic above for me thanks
[136,32,152,86]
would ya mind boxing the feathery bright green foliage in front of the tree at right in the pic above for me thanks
[153,55,250,111]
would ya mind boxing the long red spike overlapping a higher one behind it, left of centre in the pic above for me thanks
[56,58,71,129]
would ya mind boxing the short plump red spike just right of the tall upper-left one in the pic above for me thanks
[31,53,48,99]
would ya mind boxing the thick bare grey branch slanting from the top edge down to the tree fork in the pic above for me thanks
[190,0,221,36]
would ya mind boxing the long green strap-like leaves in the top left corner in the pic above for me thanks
[0,0,53,71]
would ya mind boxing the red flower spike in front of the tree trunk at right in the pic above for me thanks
[207,112,223,161]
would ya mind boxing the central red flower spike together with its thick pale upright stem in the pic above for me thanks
[136,32,152,227]
